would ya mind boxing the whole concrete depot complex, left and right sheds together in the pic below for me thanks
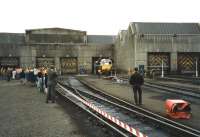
[0,22,200,75]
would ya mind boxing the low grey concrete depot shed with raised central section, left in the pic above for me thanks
[0,28,114,74]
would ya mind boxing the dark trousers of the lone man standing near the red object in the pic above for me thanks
[133,85,142,105]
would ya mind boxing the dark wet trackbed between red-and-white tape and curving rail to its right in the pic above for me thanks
[57,78,199,137]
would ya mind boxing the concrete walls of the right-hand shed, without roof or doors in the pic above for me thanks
[114,25,200,72]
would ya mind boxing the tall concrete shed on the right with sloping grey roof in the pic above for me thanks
[113,22,200,74]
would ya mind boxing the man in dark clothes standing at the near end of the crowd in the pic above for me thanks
[46,66,58,103]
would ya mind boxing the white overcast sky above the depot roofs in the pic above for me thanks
[0,0,200,35]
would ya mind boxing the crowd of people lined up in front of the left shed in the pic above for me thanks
[0,66,57,103]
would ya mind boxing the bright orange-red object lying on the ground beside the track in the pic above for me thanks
[165,99,191,119]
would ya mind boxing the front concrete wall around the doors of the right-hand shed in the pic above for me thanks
[136,36,200,71]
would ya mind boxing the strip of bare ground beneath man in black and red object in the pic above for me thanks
[79,75,200,130]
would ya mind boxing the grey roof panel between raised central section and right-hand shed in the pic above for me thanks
[87,35,115,44]
